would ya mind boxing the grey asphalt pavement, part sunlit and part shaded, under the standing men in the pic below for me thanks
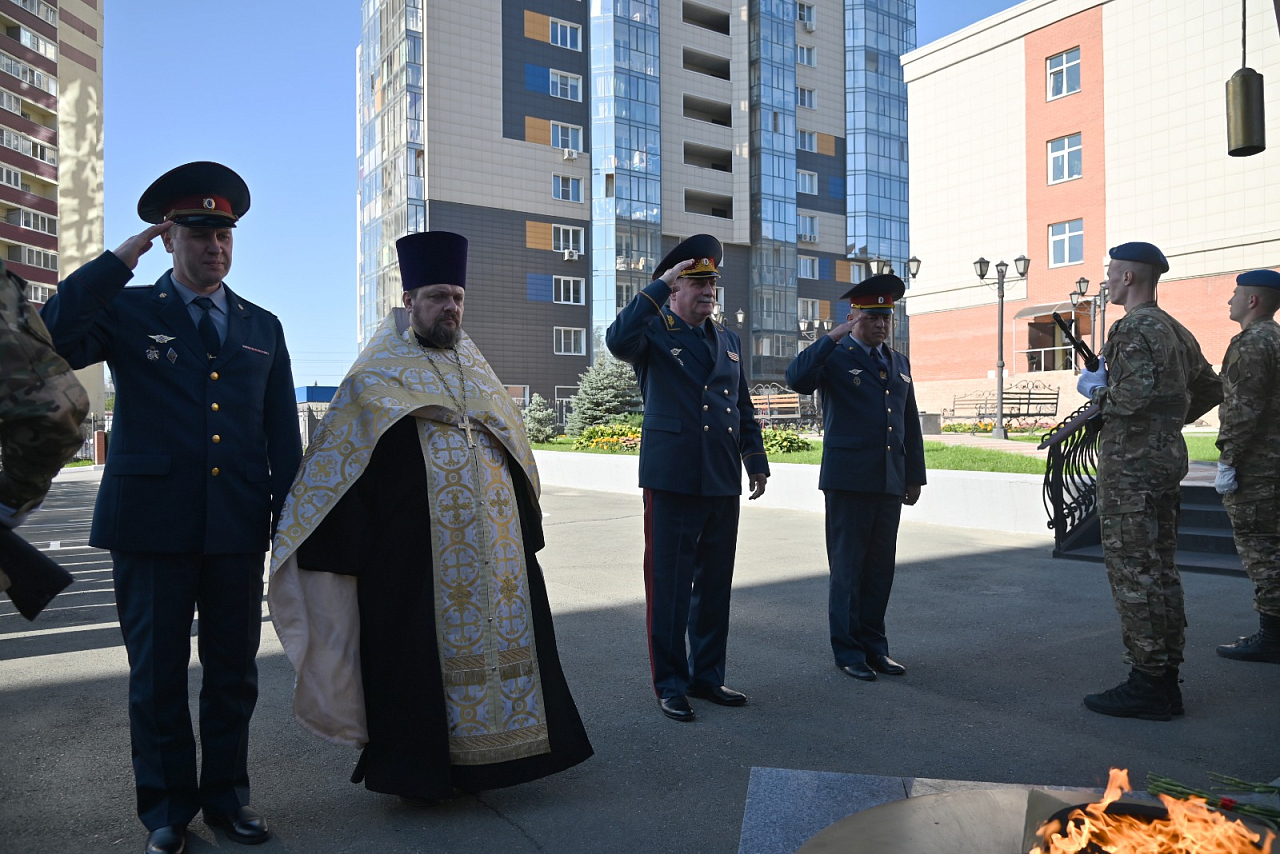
[0,475,1280,854]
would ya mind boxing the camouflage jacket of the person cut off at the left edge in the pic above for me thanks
[0,262,88,513]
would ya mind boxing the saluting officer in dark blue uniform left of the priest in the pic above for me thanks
[44,163,302,854]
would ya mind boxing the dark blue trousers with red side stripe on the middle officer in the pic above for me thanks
[644,489,741,698]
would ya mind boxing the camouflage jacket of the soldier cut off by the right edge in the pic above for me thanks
[1217,318,1280,481]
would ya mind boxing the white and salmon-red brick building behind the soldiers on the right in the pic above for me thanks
[902,0,1280,427]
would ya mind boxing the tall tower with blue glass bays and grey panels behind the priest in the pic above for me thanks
[357,0,915,415]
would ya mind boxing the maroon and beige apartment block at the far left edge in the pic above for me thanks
[0,0,104,414]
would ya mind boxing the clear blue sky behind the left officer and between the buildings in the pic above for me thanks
[104,0,1014,385]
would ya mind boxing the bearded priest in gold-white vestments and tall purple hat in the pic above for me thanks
[269,232,591,803]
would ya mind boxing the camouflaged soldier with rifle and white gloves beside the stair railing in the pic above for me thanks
[1078,243,1222,721]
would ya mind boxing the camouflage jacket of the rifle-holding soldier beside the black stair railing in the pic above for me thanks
[1093,302,1222,490]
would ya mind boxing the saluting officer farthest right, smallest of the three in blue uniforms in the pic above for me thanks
[787,275,924,681]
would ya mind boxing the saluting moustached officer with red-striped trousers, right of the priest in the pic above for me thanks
[604,234,769,721]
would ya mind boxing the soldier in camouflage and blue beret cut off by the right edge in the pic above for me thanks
[1215,270,1280,665]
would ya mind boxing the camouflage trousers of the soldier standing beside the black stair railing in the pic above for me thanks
[1098,484,1187,676]
